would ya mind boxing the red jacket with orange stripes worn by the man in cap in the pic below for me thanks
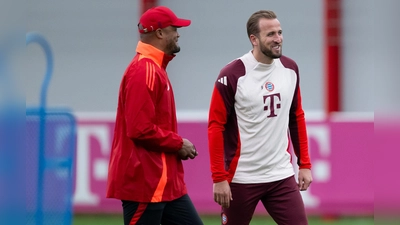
[107,41,187,202]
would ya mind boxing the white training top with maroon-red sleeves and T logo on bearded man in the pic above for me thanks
[208,51,311,184]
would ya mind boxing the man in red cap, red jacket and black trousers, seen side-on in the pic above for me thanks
[107,6,203,225]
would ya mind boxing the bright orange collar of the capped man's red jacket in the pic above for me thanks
[136,41,175,69]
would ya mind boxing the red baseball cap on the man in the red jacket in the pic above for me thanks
[138,6,191,34]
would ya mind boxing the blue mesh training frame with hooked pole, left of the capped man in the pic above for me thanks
[25,33,76,225]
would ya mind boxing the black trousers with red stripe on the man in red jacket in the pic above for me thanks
[122,195,203,225]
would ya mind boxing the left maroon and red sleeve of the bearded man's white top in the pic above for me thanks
[208,60,245,183]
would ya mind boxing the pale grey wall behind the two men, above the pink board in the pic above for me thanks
[23,0,386,112]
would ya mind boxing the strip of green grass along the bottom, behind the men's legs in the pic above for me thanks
[73,214,384,225]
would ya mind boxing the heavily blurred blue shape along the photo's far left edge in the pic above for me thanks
[0,31,26,225]
